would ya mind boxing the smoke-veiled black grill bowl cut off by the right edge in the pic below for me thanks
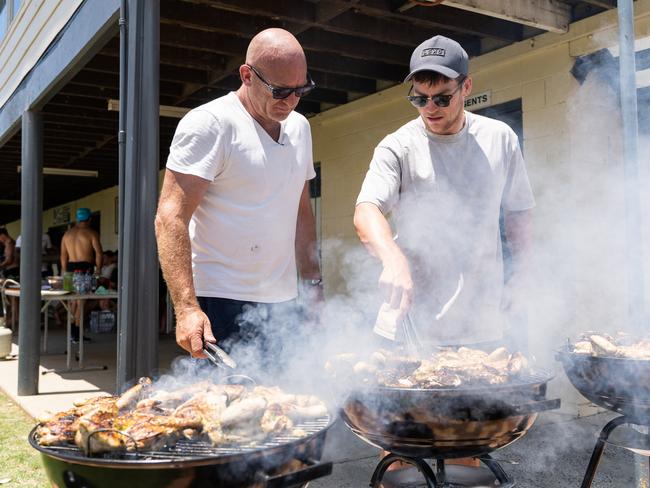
[556,347,650,419]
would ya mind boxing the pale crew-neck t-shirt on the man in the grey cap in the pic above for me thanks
[357,112,535,344]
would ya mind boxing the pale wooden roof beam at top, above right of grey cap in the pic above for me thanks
[444,0,571,34]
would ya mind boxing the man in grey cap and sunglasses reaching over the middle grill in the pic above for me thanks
[354,36,535,347]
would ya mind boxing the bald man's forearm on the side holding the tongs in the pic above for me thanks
[156,217,199,314]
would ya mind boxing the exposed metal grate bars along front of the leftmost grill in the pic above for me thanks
[40,415,331,461]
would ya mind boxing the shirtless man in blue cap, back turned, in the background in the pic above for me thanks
[61,207,103,339]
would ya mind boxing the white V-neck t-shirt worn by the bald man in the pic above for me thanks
[167,92,316,303]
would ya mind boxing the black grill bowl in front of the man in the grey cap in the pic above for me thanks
[341,373,559,458]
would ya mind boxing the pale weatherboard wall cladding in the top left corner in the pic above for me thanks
[0,0,83,107]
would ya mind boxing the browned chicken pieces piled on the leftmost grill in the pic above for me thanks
[36,378,328,453]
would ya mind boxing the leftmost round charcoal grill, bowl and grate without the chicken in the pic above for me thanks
[29,415,334,488]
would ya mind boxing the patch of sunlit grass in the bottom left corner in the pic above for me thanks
[0,392,50,488]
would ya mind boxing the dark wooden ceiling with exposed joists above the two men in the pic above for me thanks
[0,0,616,223]
